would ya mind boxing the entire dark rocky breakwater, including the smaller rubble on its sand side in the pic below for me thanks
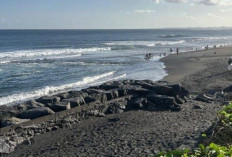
[0,80,189,153]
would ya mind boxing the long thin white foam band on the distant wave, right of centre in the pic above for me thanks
[104,40,185,47]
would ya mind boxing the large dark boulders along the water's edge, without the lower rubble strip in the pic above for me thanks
[0,80,189,127]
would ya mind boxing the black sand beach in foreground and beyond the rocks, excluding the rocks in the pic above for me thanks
[1,47,232,157]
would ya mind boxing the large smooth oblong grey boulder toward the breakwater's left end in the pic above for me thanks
[19,107,54,119]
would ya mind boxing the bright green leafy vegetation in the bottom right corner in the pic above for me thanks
[155,103,232,157]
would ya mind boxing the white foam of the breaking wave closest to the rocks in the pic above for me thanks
[0,71,115,105]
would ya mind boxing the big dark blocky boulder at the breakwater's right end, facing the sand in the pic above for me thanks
[147,95,181,111]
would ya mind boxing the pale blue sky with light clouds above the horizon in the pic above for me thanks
[0,0,232,29]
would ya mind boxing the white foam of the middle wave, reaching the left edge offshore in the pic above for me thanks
[0,47,111,59]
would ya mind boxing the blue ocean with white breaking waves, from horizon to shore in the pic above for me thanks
[0,29,232,105]
